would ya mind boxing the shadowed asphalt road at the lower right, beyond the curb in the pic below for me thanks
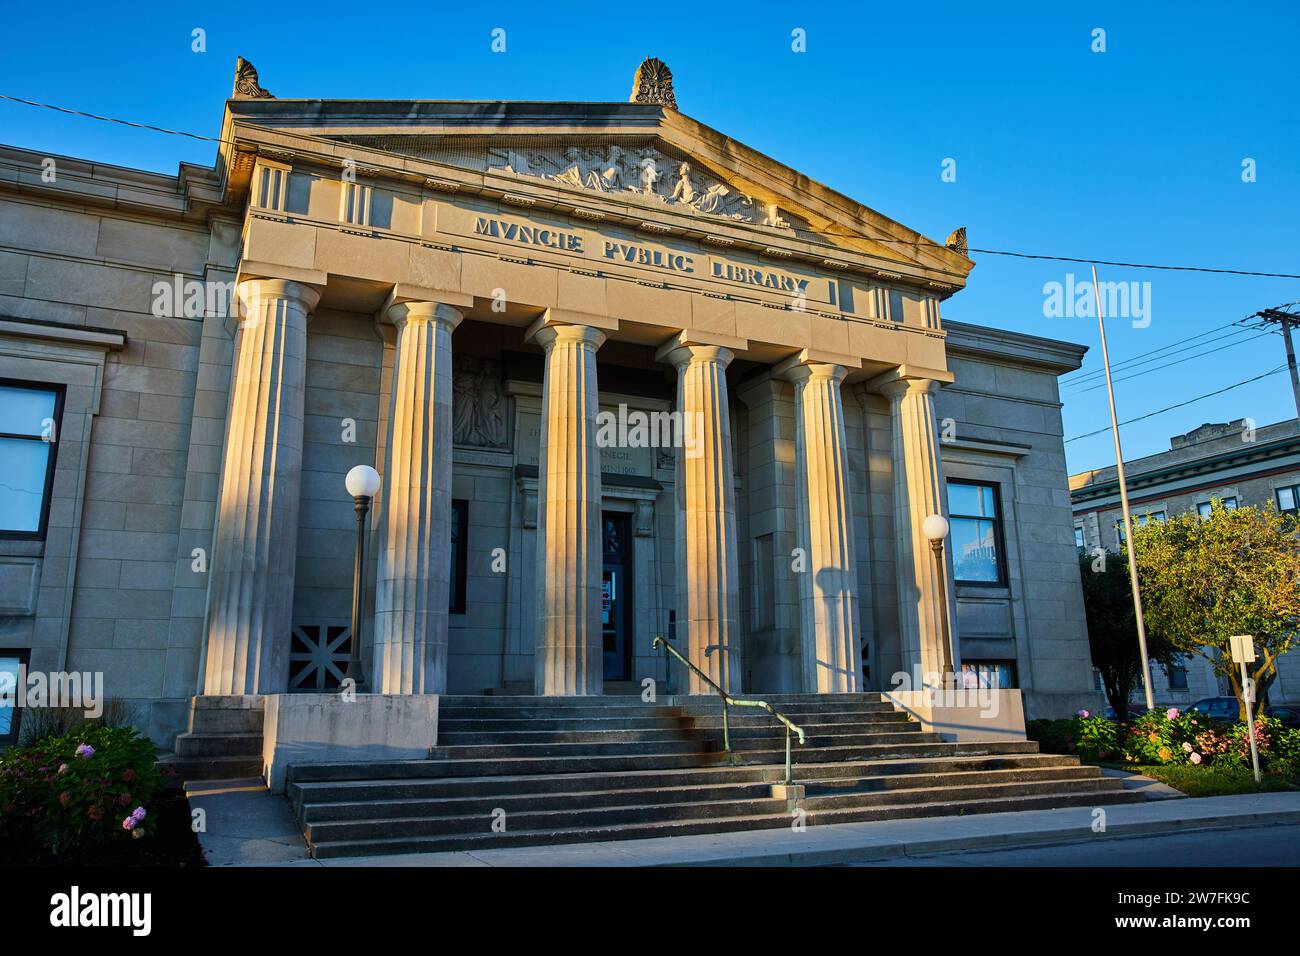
[850,825,1300,868]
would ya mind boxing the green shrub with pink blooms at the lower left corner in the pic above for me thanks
[0,723,163,853]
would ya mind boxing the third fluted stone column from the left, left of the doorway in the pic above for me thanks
[530,323,605,696]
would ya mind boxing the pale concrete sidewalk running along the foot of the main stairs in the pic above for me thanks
[190,780,1300,866]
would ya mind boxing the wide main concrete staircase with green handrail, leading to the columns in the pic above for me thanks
[287,695,1143,857]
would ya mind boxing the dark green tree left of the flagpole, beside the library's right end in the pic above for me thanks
[1079,549,1175,721]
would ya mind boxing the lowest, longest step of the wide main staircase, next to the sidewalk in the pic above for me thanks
[299,790,1144,858]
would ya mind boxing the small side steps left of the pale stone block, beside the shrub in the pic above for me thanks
[159,696,263,786]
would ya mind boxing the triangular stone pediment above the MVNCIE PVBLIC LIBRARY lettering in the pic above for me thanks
[230,99,972,286]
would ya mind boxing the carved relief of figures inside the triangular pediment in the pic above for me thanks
[488,143,794,229]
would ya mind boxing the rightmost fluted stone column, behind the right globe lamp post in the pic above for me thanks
[880,378,948,684]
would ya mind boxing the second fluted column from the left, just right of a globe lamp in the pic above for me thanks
[369,302,464,693]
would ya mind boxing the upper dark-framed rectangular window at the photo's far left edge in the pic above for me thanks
[0,380,64,538]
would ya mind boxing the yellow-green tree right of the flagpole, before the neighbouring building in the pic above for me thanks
[1134,502,1300,721]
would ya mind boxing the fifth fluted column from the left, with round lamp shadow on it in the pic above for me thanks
[781,362,862,693]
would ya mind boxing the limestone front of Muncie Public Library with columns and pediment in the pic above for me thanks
[0,78,1097,741]
